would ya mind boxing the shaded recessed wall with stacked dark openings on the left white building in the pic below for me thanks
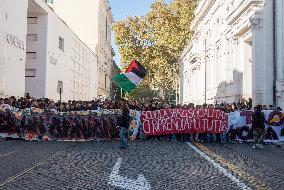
[25,0,48,98]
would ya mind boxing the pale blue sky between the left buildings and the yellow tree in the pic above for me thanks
[109,0,171,66]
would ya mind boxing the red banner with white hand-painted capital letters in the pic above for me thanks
[141,109,228,135]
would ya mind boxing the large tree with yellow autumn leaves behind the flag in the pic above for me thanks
[113,0,196,101]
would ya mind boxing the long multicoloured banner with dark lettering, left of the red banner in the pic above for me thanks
[0,107,136,141]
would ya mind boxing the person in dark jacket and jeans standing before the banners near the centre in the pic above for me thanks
[118,102,130,149]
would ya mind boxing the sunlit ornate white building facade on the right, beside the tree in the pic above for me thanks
[181,0,263,104]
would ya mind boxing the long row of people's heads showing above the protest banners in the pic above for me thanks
[0,95,282,113]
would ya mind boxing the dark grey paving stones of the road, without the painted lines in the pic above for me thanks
[0,141,284,190]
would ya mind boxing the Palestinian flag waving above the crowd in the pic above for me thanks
[112,60,147,92]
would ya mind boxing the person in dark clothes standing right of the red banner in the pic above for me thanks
[252,105,266,148]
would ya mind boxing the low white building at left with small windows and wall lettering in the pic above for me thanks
[0,0,101,100]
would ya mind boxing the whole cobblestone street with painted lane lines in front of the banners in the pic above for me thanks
[0,141,284,189]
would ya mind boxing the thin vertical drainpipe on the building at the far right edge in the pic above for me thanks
[272,0,277,108]
